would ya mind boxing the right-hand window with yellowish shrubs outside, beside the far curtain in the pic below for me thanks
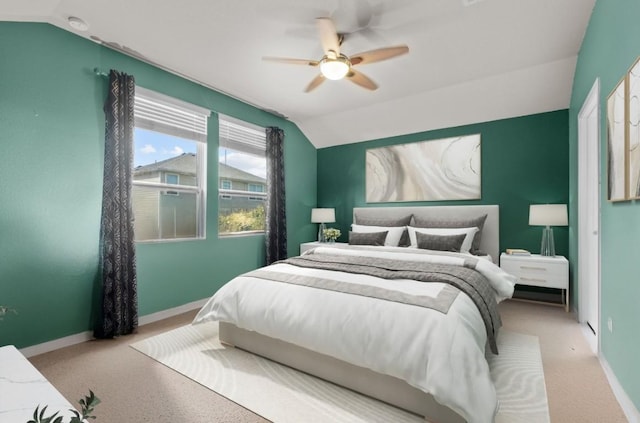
[218,115,267,236]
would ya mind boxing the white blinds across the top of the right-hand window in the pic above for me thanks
[218,114,267,157]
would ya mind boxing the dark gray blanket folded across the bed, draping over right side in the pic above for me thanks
[272,254,502,354]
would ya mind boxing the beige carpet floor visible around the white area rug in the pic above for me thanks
[29,301,627,423]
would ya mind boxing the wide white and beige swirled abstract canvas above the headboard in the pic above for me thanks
[366,134,481,203]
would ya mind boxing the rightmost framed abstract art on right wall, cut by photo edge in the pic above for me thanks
[627,59,640,199]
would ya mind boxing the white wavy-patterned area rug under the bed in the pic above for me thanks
[131,323,549,423]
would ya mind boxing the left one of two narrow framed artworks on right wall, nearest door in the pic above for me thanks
[607,77,627,201]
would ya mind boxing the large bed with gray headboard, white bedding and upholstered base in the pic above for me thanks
[194,206,515,422]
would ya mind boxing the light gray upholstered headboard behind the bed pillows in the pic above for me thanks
[353,205,500,264]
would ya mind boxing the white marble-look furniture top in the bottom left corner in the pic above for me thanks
[0,345,74,423]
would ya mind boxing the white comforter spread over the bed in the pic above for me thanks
[194,247,515,423]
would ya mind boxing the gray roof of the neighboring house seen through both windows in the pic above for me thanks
[133,153,267,184]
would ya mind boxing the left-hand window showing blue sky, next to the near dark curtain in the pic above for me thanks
[132,87,210,241]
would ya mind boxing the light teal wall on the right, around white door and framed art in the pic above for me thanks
[569,0,640,409]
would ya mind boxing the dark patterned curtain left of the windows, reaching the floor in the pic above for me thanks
[94,70,138,338]
